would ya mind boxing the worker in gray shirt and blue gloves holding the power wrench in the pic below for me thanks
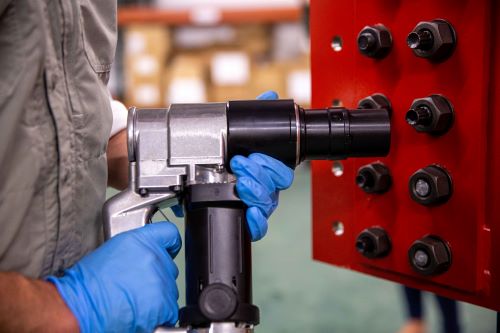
[0,0,293,332]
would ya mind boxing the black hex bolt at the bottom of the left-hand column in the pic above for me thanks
[356,227,391,259]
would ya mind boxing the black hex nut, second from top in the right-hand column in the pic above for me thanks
[406,95,455,135]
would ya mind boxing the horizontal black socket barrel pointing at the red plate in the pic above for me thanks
[227,100,391,168]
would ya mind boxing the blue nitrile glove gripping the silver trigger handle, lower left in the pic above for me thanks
[47,222,181,333]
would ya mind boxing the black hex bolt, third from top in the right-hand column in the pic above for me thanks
[408,165,453,206]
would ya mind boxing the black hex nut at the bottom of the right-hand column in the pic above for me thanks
[408,235,451,275]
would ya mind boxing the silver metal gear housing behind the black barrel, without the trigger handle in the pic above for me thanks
[129,103,227,190]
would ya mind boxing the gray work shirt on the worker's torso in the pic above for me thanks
[0,0,116,277]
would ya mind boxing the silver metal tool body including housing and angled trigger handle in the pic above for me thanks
[103,103,235,238]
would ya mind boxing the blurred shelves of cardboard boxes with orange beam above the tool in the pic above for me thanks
[110,0,311,107]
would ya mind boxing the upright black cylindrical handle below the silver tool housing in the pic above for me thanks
[179,183,259,327]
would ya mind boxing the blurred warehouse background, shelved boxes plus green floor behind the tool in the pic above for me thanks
[108,0,496,333]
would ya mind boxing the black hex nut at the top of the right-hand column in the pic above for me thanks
[407,19,457,61]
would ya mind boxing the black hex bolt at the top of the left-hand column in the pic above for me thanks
[357,24,392,58]
